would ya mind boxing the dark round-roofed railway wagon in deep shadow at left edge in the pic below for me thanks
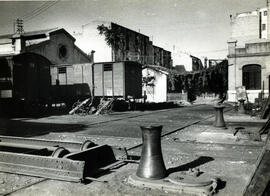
[0,53,51,113]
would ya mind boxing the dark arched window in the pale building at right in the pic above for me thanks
[243,64,261,90]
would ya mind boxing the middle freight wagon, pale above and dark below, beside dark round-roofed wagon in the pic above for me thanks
[51,63,92,108]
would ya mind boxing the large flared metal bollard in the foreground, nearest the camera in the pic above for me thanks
[136,126,167,180]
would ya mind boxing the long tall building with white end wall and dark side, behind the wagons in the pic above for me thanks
[74,22,172,68]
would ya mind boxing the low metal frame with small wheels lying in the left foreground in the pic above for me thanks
[0,136,128,182]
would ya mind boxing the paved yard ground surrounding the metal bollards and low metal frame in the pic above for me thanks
[0,104,265,196]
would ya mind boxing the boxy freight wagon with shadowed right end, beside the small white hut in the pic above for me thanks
[93,61,142,99]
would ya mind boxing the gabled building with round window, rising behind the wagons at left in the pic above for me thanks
[0,28,91,65]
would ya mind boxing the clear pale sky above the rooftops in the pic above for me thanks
[0,0,266,69]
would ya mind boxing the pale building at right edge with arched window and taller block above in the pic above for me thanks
[228,2,270,102]
